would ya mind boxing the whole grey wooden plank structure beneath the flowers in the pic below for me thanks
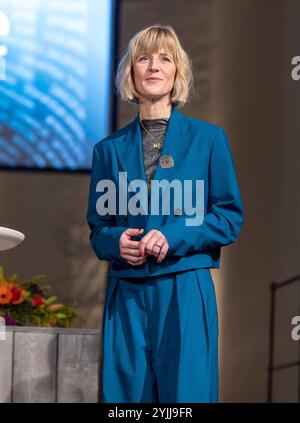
[0,326,100,403]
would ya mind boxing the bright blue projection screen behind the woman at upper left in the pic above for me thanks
[0,0,114,170]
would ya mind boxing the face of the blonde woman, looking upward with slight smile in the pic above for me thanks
[133,49,176,103]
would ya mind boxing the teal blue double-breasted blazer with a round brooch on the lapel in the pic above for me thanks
[87,106,244,278]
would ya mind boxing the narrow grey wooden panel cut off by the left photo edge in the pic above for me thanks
[0,331,13,403]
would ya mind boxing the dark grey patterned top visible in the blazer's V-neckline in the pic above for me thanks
[140,118,169,198]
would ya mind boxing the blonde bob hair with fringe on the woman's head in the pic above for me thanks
[115,25,193,107]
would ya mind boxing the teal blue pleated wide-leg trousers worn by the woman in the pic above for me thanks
[101,268,219,403]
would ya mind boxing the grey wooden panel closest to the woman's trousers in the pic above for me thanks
[57,334,99,403]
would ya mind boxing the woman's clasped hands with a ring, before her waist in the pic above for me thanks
[119,228,169,266]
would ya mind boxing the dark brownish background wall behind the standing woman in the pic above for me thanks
[0,0,300,402]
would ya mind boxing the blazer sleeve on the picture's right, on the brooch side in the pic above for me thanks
[157,128,244,256]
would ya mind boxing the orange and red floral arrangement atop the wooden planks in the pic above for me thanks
[0,266,87,328]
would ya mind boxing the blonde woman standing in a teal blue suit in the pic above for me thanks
[87,25,243,403]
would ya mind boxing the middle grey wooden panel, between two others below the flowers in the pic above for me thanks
[13,331,57,403]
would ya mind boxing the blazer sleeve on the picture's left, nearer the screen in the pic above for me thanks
[87,144,127,264]
